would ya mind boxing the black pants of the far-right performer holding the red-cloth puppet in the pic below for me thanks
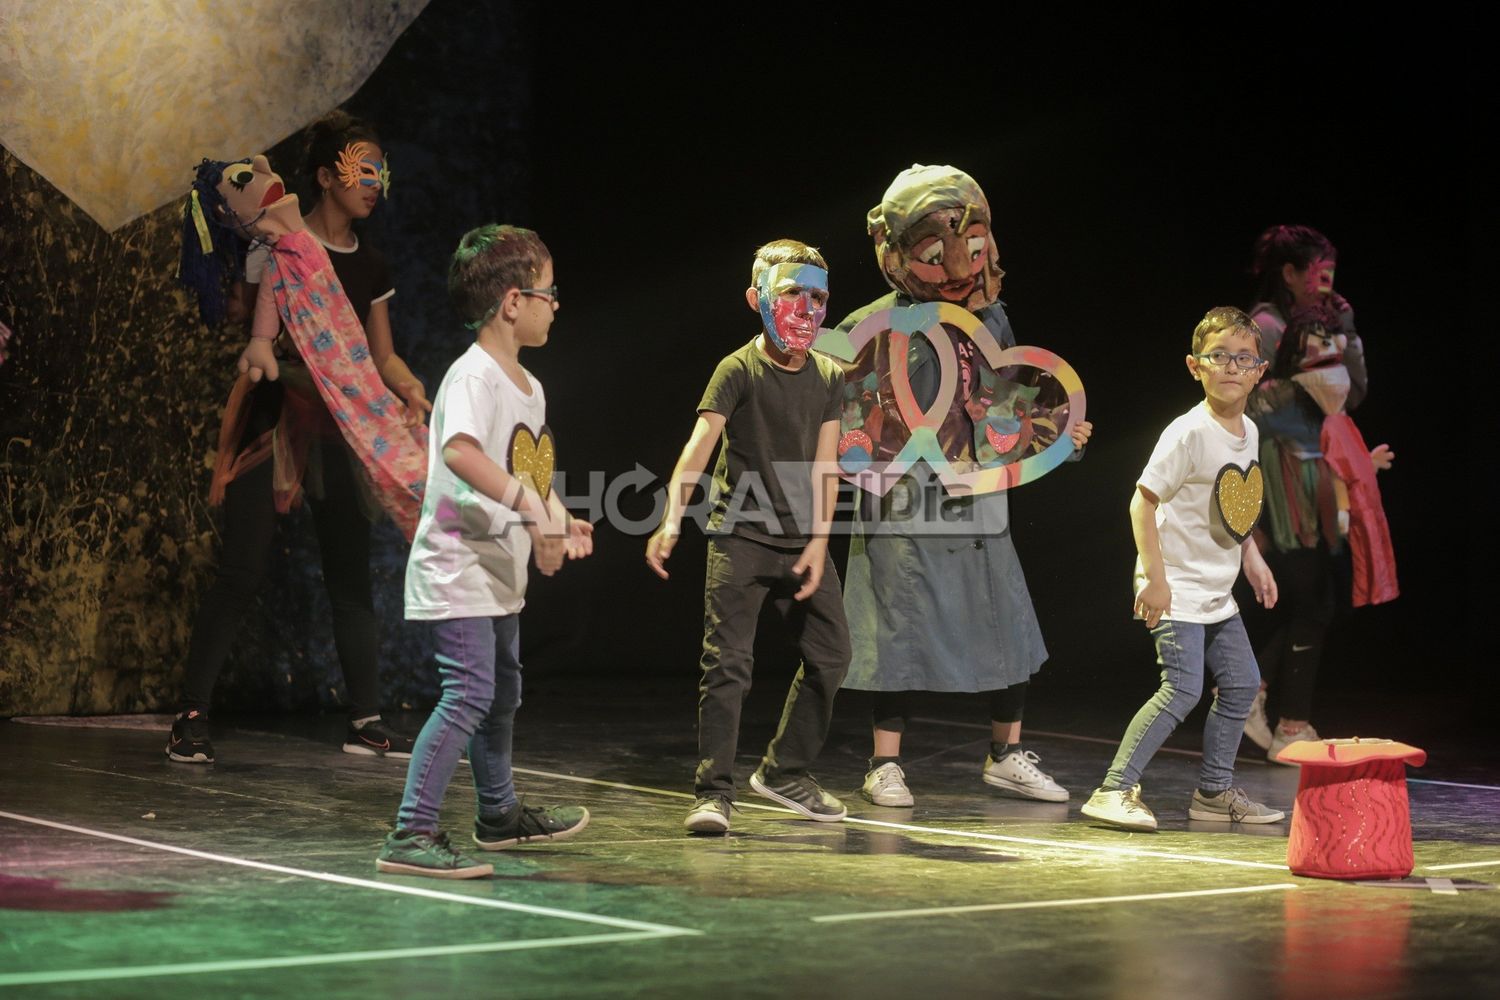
[1256,549,1337,720]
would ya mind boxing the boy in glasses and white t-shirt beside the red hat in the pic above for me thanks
[1083,307,1284,831]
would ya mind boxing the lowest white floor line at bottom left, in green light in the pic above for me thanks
[0,931,677,987]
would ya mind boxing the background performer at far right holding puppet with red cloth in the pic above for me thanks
[1245,226,1398,763]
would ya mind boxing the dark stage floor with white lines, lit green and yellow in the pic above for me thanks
[0,681,1500,1000]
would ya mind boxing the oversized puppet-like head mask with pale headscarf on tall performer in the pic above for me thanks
[866,163,1005,310]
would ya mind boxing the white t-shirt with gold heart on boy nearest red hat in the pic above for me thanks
[1136,402,1265,625]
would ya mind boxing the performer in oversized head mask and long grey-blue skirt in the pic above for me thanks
[819,165,1082,805]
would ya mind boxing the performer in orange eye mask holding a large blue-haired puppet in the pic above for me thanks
[167,112,431,763]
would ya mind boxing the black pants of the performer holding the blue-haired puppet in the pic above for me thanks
[183,441,380,718]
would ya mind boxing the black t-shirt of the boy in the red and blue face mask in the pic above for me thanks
[698,340,843,547]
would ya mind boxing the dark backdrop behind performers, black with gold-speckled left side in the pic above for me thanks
[0,0,1494,726]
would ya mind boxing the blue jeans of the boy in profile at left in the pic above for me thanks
[396,615,521,834]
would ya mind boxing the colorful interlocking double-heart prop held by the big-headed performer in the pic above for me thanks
[813,303,1085,496]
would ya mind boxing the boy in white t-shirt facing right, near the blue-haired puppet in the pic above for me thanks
[375,225,594,879]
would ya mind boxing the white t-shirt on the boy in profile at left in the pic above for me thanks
[407,343,546,621]
